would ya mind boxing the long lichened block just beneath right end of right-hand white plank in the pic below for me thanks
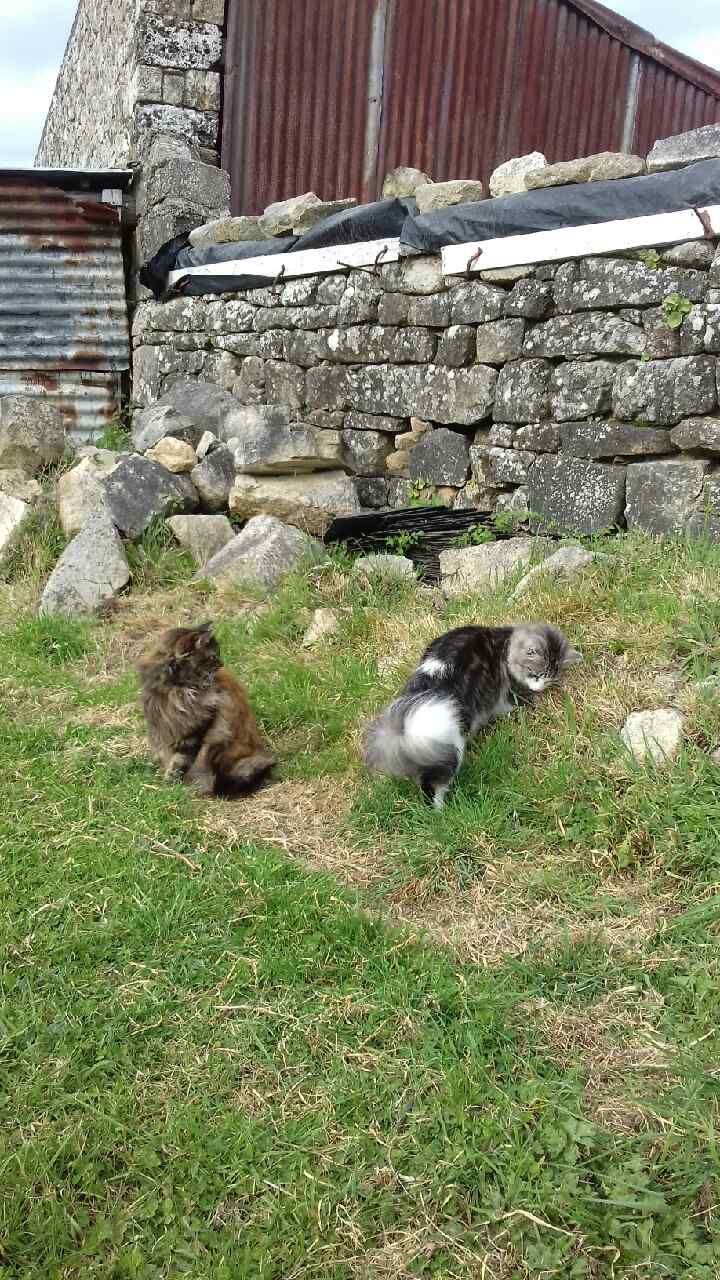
[553,257,707,312]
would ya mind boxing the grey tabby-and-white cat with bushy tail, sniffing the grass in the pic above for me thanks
[364,622,582,809]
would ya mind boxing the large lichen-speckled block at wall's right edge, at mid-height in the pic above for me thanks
[612,356,717,426]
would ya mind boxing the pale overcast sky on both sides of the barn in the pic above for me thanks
[0,0,720,166]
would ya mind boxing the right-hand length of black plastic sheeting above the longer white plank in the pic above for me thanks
[401,160,720,253]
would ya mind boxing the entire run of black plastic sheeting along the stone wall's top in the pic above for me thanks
[140,160,720,298]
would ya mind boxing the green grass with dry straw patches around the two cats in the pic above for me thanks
[0,531,720,1280]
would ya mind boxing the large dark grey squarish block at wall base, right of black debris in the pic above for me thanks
[528,453,625,534]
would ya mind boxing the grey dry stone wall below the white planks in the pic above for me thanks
[133,241,720,536]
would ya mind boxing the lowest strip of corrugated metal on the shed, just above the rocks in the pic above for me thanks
[0,369,122,443]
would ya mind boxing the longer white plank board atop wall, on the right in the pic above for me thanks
[442,205,720,275]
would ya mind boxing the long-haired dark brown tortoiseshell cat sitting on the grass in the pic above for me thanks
[137,622,274,796]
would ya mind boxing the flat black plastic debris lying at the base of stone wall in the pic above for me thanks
[324,507,514,582]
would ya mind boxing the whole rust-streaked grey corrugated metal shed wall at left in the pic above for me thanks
[0,174,129,435]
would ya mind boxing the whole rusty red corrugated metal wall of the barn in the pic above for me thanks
[223,0,720,212]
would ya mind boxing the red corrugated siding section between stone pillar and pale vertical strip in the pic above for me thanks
[222,0,375,212]
